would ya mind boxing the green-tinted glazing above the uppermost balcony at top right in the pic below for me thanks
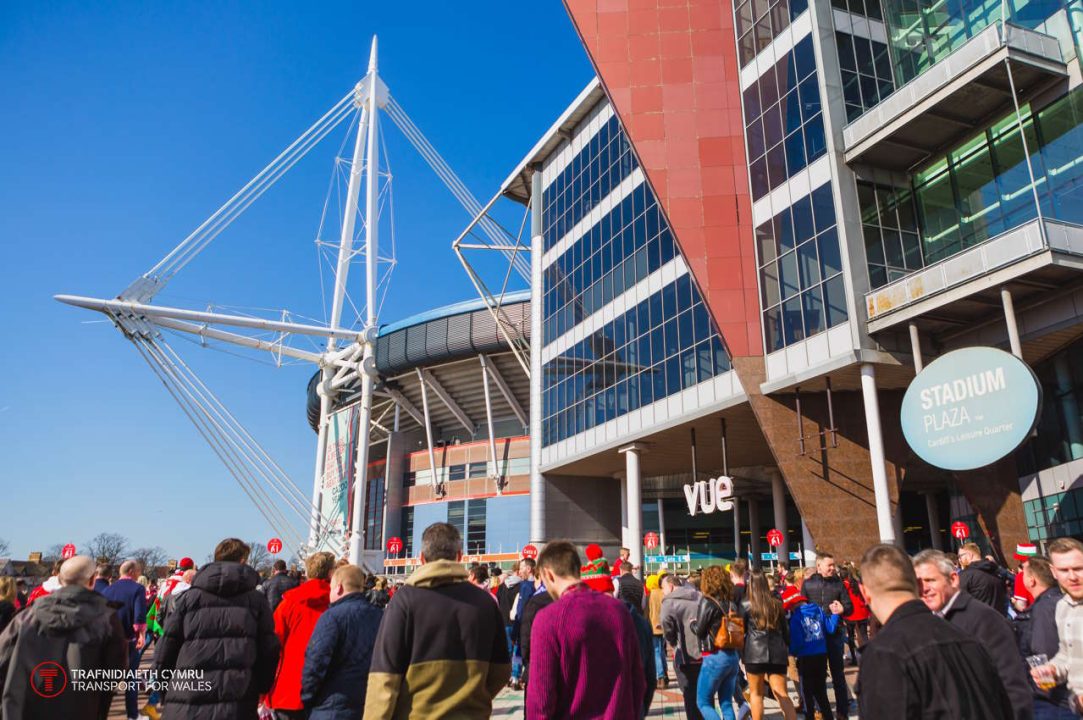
[884,0,1071,86]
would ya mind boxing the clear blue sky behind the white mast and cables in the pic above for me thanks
[0,0,592,561]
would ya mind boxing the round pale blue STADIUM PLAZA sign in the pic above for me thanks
[901,348,1042,470]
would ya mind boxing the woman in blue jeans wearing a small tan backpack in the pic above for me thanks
[691,565,741,720]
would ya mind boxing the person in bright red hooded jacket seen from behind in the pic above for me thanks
[268,552,335,720]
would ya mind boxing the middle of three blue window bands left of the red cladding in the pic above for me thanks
[543,183,677,344]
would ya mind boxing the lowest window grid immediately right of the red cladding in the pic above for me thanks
[756,182,847,353]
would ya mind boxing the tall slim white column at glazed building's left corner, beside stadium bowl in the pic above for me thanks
[530,166,548,542]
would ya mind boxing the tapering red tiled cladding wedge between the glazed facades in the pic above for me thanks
[564,0,764,357]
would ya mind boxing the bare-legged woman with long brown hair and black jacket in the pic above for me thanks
[741,570,797,720]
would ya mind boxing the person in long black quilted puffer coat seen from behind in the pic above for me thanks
[155,538,282,720]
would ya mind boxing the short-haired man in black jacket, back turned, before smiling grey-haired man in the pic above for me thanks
[857,545,1014,720]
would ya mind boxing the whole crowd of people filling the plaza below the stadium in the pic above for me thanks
[0,523,1083,720]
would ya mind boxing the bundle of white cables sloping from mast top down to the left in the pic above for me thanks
[146,93,354,283]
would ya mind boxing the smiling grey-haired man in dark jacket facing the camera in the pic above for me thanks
[914,550,1034,720]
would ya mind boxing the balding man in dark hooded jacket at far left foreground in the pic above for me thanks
[0,555,128,720]
